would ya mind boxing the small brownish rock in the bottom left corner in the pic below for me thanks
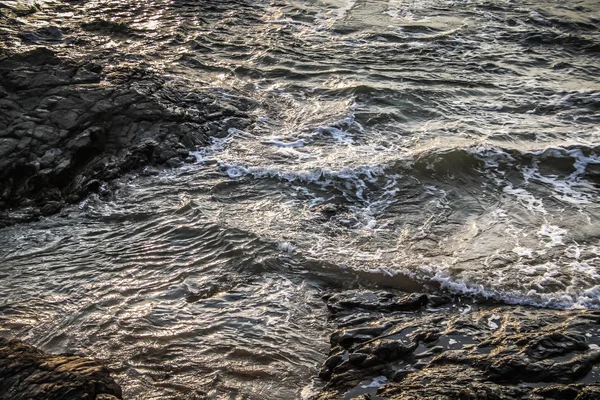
[0,338,122,400]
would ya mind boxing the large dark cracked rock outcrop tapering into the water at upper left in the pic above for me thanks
[0,47,254,227]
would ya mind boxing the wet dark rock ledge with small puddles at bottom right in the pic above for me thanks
[318,291,600,400]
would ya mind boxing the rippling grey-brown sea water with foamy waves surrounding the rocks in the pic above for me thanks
[0,0,600,399]
